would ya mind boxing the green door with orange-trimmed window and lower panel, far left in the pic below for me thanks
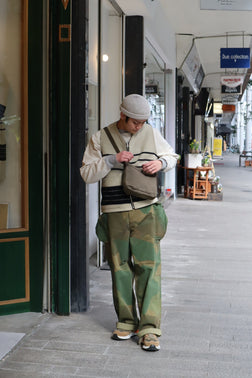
[0,0,43,314]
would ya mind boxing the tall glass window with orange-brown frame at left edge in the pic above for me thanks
[0,0,28,231]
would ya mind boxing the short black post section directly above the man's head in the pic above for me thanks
[125,16,144,96]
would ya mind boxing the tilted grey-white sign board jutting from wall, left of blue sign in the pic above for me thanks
[182,45,205,93]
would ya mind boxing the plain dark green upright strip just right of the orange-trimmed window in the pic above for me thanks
[28,1,43,312]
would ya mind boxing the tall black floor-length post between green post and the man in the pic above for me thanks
[71,0,89,312]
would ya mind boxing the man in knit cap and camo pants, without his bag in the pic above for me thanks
[80,94,178,351]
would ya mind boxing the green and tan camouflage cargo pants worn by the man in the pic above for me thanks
[96,203,167,337]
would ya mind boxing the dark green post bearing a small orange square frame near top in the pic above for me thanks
[49,1,71,315]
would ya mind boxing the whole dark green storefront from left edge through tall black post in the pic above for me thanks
[0,0,88,315]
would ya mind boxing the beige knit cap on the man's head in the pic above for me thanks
[120,94,150,120]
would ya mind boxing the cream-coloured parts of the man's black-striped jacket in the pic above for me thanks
[80,123,178,212]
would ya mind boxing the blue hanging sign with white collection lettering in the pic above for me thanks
[220,47,250,68]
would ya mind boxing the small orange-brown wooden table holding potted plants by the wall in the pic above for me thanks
[183,167,213,199]
